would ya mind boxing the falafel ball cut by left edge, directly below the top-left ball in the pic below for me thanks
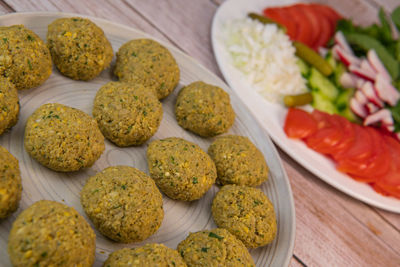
[0,77,19,135]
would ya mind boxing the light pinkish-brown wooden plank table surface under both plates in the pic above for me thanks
[0,0,400,266]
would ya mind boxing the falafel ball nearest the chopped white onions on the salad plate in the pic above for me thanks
[175,82,235,137]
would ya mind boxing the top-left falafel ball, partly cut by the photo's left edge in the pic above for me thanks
[0,25,52,90]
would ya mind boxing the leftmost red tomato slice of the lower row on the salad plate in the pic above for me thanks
[283,108,317,138]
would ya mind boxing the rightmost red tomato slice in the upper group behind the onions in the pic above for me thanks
[310,4,336,50]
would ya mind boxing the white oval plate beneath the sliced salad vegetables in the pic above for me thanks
[211,0,400,213]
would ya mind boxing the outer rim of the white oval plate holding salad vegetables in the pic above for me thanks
[211,0,400,213]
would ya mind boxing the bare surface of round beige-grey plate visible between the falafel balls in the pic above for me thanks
[0,13,295,266]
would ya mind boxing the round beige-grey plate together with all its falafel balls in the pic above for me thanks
[0,13,295,267]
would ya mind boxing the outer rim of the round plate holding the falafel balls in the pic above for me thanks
[0,11,296,266]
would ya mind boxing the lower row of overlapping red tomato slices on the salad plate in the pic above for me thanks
[284,108,400,197]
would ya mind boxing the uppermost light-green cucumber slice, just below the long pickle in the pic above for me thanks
[309,68,339,102]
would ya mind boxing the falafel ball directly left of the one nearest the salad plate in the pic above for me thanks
[93,82,163,147]
